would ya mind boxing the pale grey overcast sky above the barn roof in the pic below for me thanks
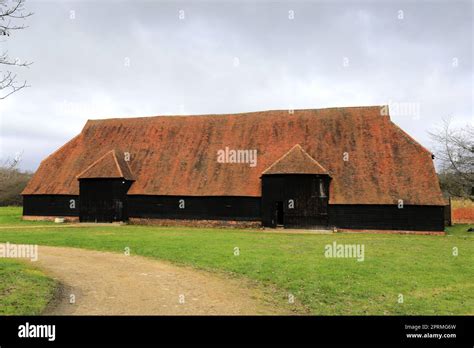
[0,0,474,170]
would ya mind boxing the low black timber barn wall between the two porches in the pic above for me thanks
[127,195,260,221]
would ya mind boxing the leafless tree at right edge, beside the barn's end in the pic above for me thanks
[430,120,474,198]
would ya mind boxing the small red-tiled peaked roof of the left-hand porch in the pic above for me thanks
[77,149,134,180]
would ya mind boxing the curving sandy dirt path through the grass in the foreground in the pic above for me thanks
[35,246,284,315]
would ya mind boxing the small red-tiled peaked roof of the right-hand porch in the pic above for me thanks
[262,144,329,175]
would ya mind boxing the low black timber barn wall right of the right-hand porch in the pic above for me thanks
[329,205,444,231]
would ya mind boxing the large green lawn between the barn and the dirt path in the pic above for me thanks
[0,208,474,315]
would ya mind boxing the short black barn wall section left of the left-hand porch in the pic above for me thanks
[23,195,79,216]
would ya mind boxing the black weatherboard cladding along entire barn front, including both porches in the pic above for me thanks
[23,186,445,231]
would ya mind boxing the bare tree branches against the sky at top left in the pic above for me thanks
[0,0,33,100]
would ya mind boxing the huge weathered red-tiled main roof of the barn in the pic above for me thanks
[23,106,445,205]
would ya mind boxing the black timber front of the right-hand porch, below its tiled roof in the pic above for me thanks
[262,174,329,228]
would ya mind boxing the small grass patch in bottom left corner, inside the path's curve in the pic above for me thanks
[0,259,56,315]
